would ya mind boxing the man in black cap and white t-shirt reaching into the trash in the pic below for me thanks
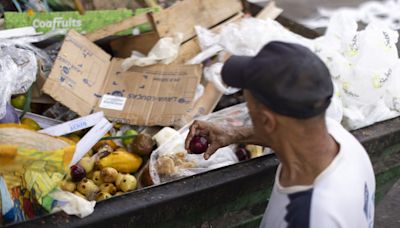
[186,42,375,228]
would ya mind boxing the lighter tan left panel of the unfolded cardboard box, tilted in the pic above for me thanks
[43,30,111,116]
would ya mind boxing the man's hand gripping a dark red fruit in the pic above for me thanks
[185,120,235,160]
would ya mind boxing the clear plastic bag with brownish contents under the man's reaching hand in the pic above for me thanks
[149,103,251,184]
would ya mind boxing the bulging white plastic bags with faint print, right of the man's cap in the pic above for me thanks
[316,14,400,130]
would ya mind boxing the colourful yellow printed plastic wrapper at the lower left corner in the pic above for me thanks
[0,124,74,223]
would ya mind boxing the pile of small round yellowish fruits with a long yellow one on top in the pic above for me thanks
[60,130,155,201]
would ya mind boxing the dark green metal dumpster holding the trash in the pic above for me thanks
[6,1,400,227]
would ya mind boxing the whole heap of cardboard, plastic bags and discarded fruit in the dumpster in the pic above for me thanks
[0,0,400,224]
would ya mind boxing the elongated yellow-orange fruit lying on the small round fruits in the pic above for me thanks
[98,150,143,173]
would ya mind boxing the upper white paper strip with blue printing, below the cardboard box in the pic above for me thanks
[39,112,104,136]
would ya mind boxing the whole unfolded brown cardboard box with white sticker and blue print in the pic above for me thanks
[43,30,202,126]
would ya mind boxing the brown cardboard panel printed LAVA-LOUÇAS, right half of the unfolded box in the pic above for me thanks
[96,59,201,126]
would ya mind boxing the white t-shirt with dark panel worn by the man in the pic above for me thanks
[260,118,375,228]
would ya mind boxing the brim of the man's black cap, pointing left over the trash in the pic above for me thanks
[221,56,252,89]
